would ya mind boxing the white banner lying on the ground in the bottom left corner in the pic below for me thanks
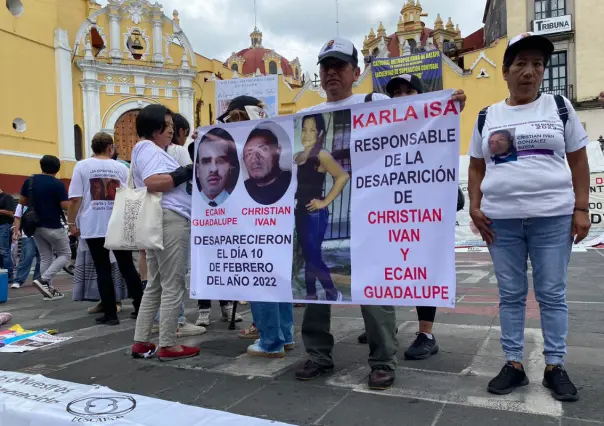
[0,371,286,426]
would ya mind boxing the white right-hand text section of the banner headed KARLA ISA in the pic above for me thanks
[350,91,459,307]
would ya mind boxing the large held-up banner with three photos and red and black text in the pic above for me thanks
[191,91,459,307]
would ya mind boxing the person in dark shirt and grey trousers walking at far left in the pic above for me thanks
[18,155,71,300]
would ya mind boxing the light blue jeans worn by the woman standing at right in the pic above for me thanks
[489,216,572,365]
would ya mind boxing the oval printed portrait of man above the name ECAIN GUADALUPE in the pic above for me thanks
[195,128,240,207]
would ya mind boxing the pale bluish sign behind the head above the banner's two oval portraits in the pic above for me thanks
[216,75,279,117]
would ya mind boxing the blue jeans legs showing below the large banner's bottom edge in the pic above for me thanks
[250,302,294,352]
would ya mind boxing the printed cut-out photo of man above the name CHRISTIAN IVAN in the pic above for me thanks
[243,125,292,206]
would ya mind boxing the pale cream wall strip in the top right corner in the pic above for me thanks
[574,0,604,101]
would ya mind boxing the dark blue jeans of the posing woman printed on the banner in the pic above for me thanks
[296,208,338,300]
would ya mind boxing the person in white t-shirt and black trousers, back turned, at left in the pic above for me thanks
[68,133,143,325]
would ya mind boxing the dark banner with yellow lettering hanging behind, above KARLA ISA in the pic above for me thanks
[371,49,443,93]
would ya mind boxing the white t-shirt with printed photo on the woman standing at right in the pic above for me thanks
[469,94,589,219]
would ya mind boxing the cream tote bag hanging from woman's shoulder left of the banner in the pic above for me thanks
[105,164,164,250]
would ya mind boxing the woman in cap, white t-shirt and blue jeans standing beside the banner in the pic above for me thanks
[469,33,590,401]
